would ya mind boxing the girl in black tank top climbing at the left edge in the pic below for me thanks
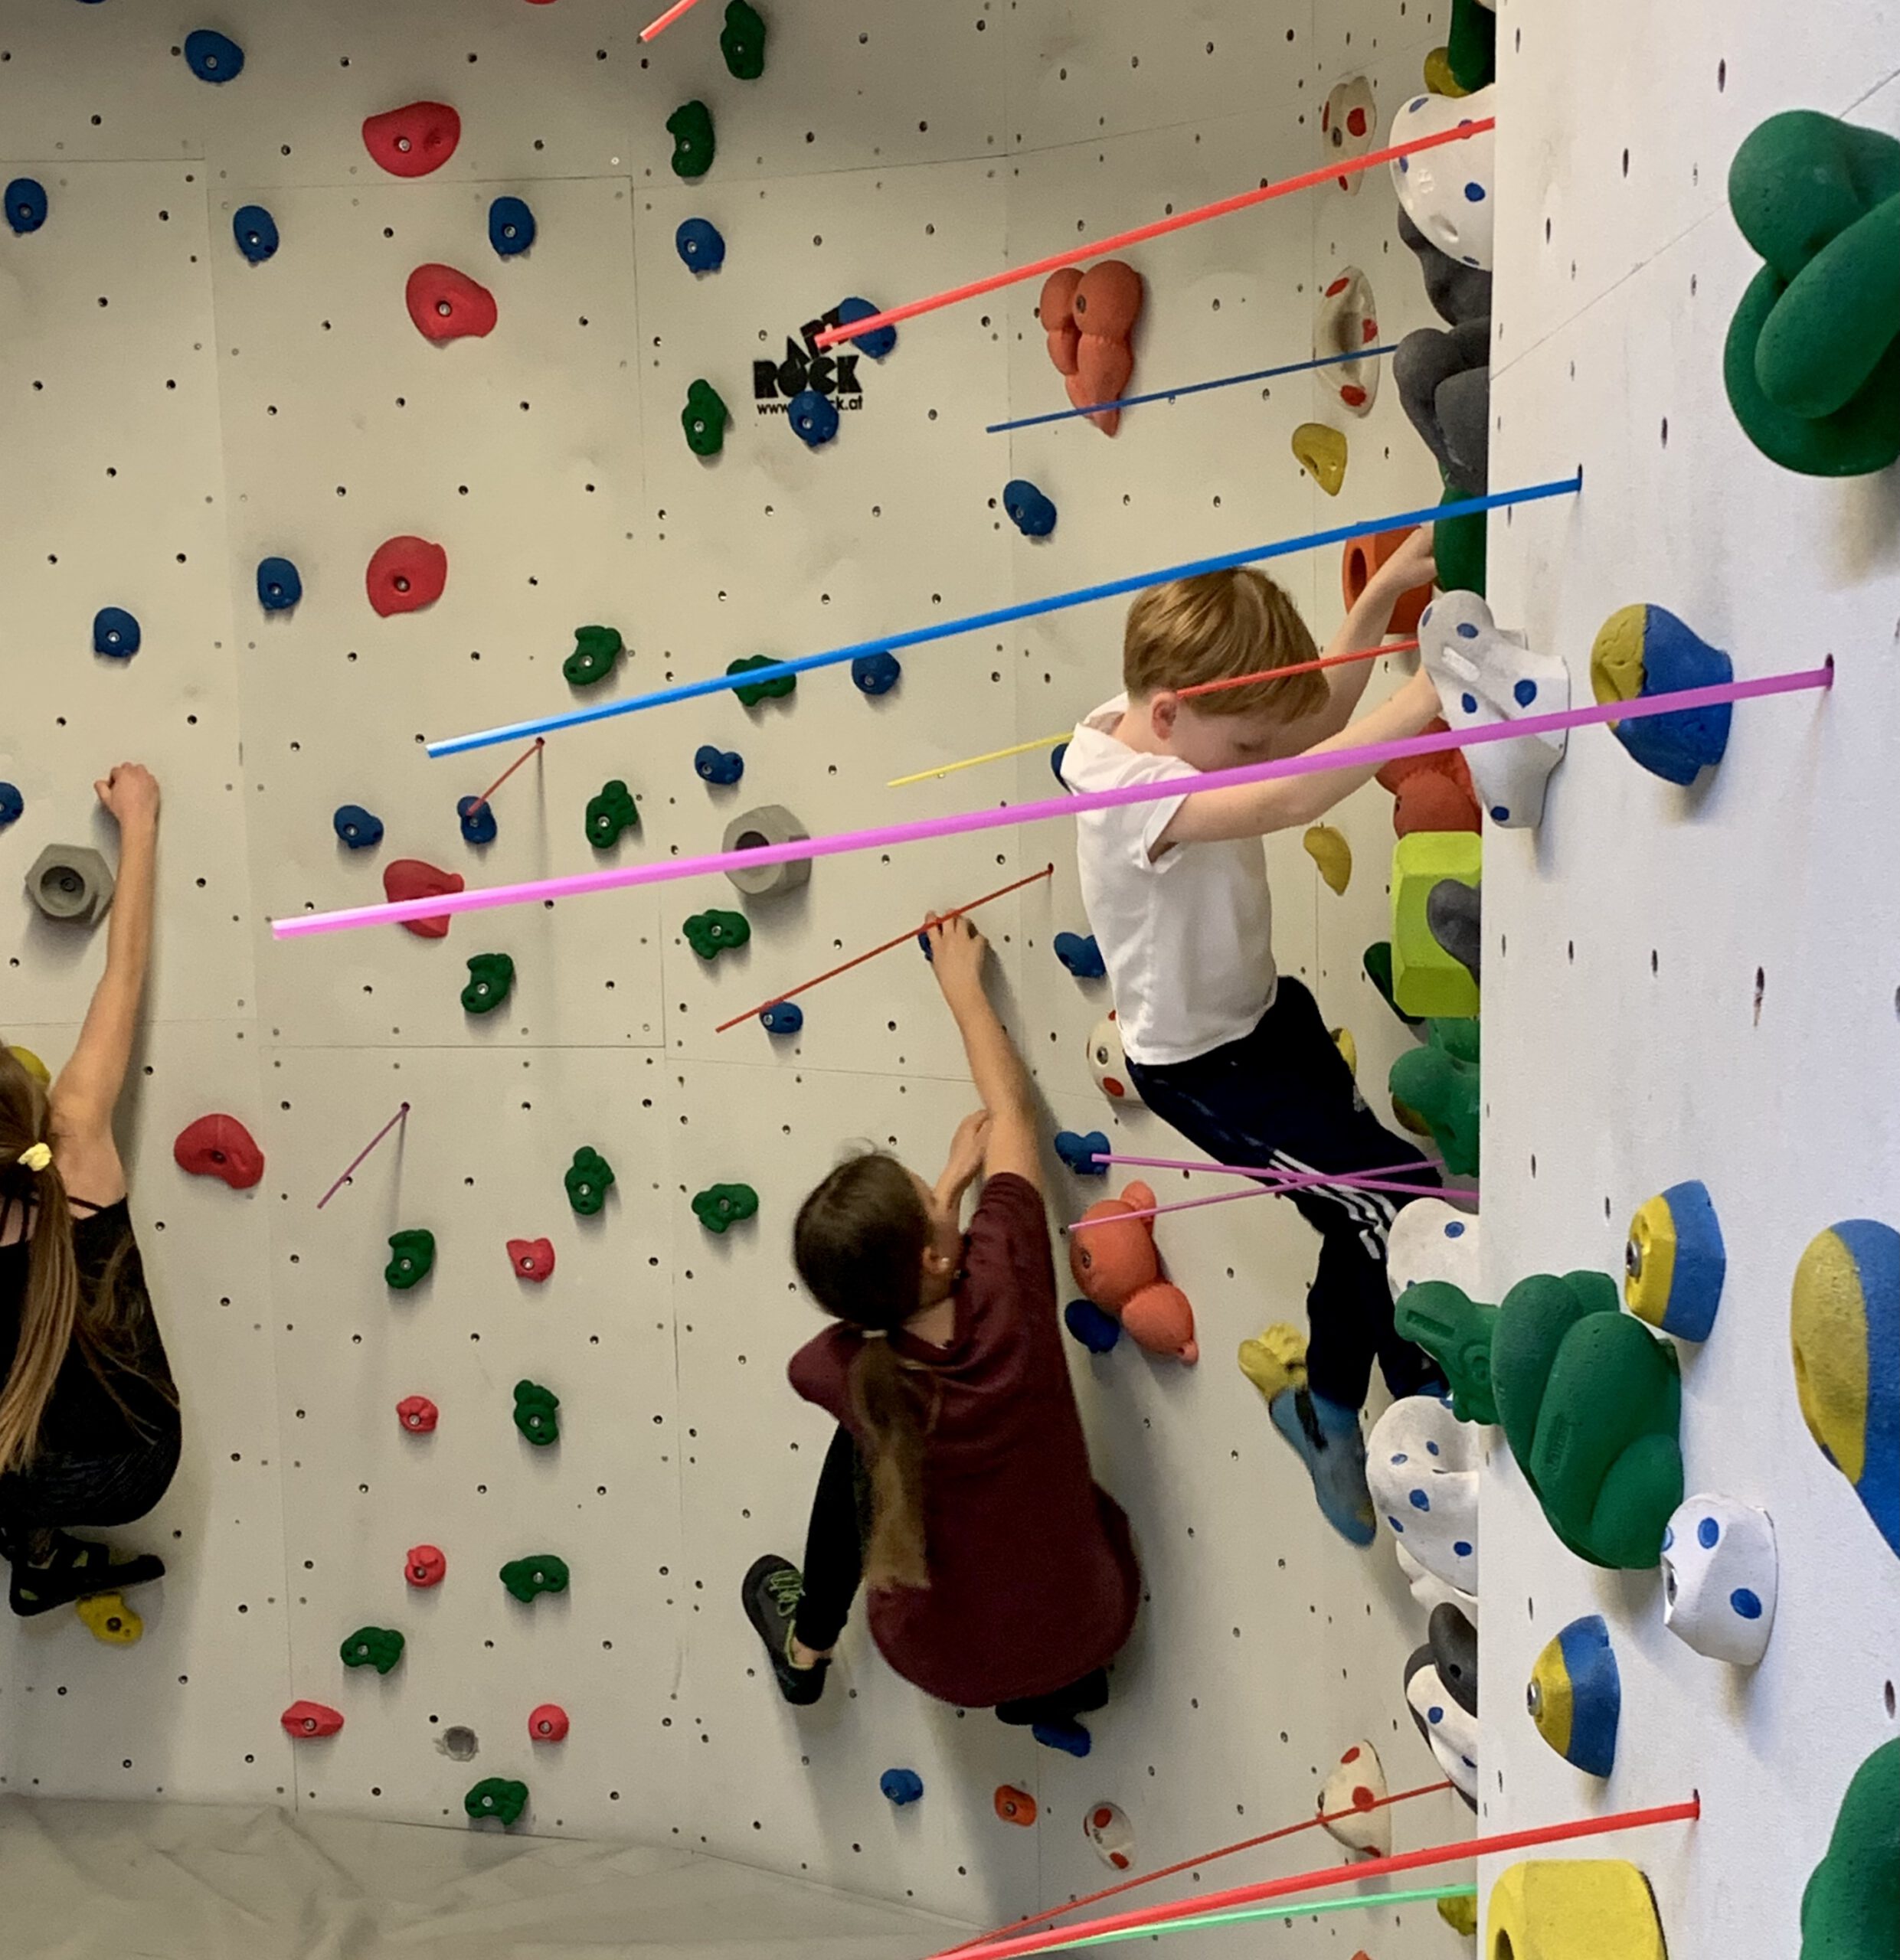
[0,763,178,1615]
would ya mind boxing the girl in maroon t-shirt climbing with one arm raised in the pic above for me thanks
[743,917,1141,1756]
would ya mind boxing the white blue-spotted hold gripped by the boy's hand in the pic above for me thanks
[1418,592,1571,829]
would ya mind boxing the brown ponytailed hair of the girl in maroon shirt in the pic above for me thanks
[792,1151,937,1588]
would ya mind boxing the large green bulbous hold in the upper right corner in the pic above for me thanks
[1722,109,1900,476]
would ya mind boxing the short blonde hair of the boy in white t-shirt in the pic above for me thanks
[1122,567,1327,721]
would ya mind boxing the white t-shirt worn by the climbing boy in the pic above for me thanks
[1063,694,1278,1068]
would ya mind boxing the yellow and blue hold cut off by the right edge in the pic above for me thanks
[1788,1219,1900,1553]
